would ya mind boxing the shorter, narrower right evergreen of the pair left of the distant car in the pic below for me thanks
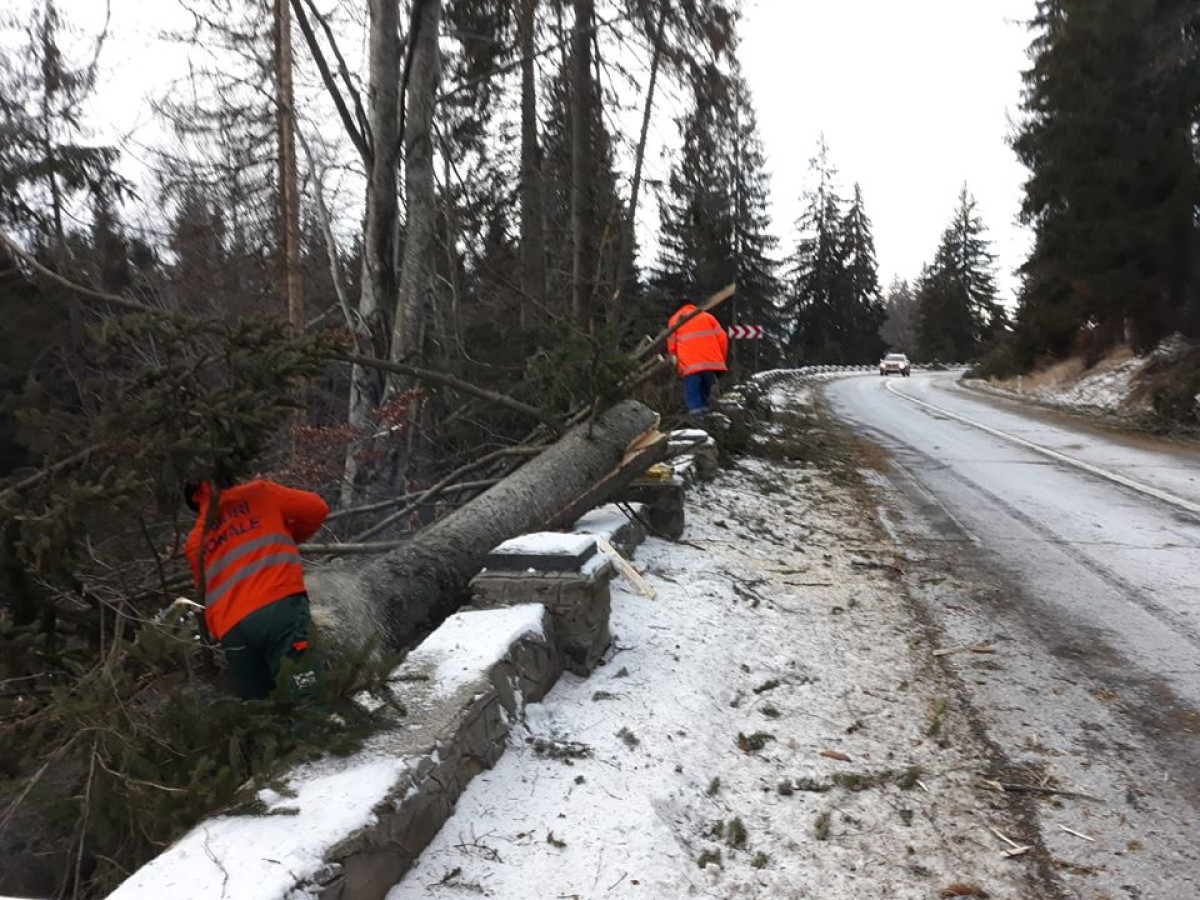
[838,185,887,364]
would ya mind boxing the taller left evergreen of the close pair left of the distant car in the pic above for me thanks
[786,137,850,364]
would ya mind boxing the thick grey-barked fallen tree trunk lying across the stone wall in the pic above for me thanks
[308,400,666,648]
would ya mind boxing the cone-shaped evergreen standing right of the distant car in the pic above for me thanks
[917,185,1007,362]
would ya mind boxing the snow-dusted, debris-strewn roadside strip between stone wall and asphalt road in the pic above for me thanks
[389,382,1040,900]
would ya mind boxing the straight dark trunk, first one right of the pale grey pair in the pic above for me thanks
[520,0,546,328]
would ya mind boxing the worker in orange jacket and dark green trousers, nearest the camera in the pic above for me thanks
[184,481,329,700]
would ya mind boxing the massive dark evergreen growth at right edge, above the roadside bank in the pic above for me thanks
[1014,0,1200,354]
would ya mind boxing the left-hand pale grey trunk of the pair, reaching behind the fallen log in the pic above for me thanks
[342,0,401,504]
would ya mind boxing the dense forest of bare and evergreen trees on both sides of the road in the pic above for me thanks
[0,0,1200,896]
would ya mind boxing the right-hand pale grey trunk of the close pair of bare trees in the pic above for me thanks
[389,0,442,374]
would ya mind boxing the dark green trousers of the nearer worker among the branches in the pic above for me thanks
[221,594,314,700]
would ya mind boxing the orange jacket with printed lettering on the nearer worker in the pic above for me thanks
[184,481,329,638]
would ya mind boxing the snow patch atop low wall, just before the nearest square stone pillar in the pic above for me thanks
[402,604,545,694]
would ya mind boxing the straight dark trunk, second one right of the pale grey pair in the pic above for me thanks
[571,0,595,324]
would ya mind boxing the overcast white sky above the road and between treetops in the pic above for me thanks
[16,0,1034,300]
